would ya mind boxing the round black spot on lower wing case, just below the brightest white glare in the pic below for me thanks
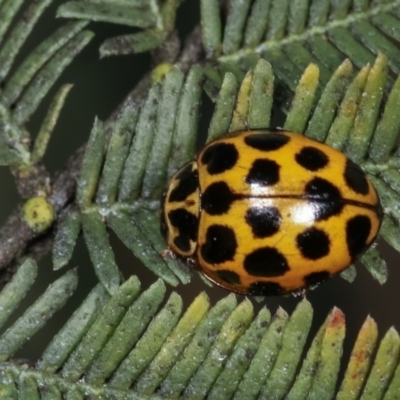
[296,228,330,260]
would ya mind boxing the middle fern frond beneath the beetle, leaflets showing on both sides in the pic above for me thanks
[53,55,400,294]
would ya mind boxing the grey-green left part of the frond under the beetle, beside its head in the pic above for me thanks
[53,67,202,293]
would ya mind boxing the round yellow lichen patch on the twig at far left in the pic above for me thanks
[22,197,54,232]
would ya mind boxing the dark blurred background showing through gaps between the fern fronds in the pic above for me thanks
[0,1,400,384]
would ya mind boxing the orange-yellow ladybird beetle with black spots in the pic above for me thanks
[161,130,383,296]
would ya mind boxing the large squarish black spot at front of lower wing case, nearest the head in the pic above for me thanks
[200,225,237,264]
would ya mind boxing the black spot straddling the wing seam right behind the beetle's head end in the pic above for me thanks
[201,181,236,215]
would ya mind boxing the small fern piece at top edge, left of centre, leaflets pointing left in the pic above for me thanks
[57,0,179,57]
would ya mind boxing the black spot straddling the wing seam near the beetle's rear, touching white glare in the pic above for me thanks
[305,178,344,221]
